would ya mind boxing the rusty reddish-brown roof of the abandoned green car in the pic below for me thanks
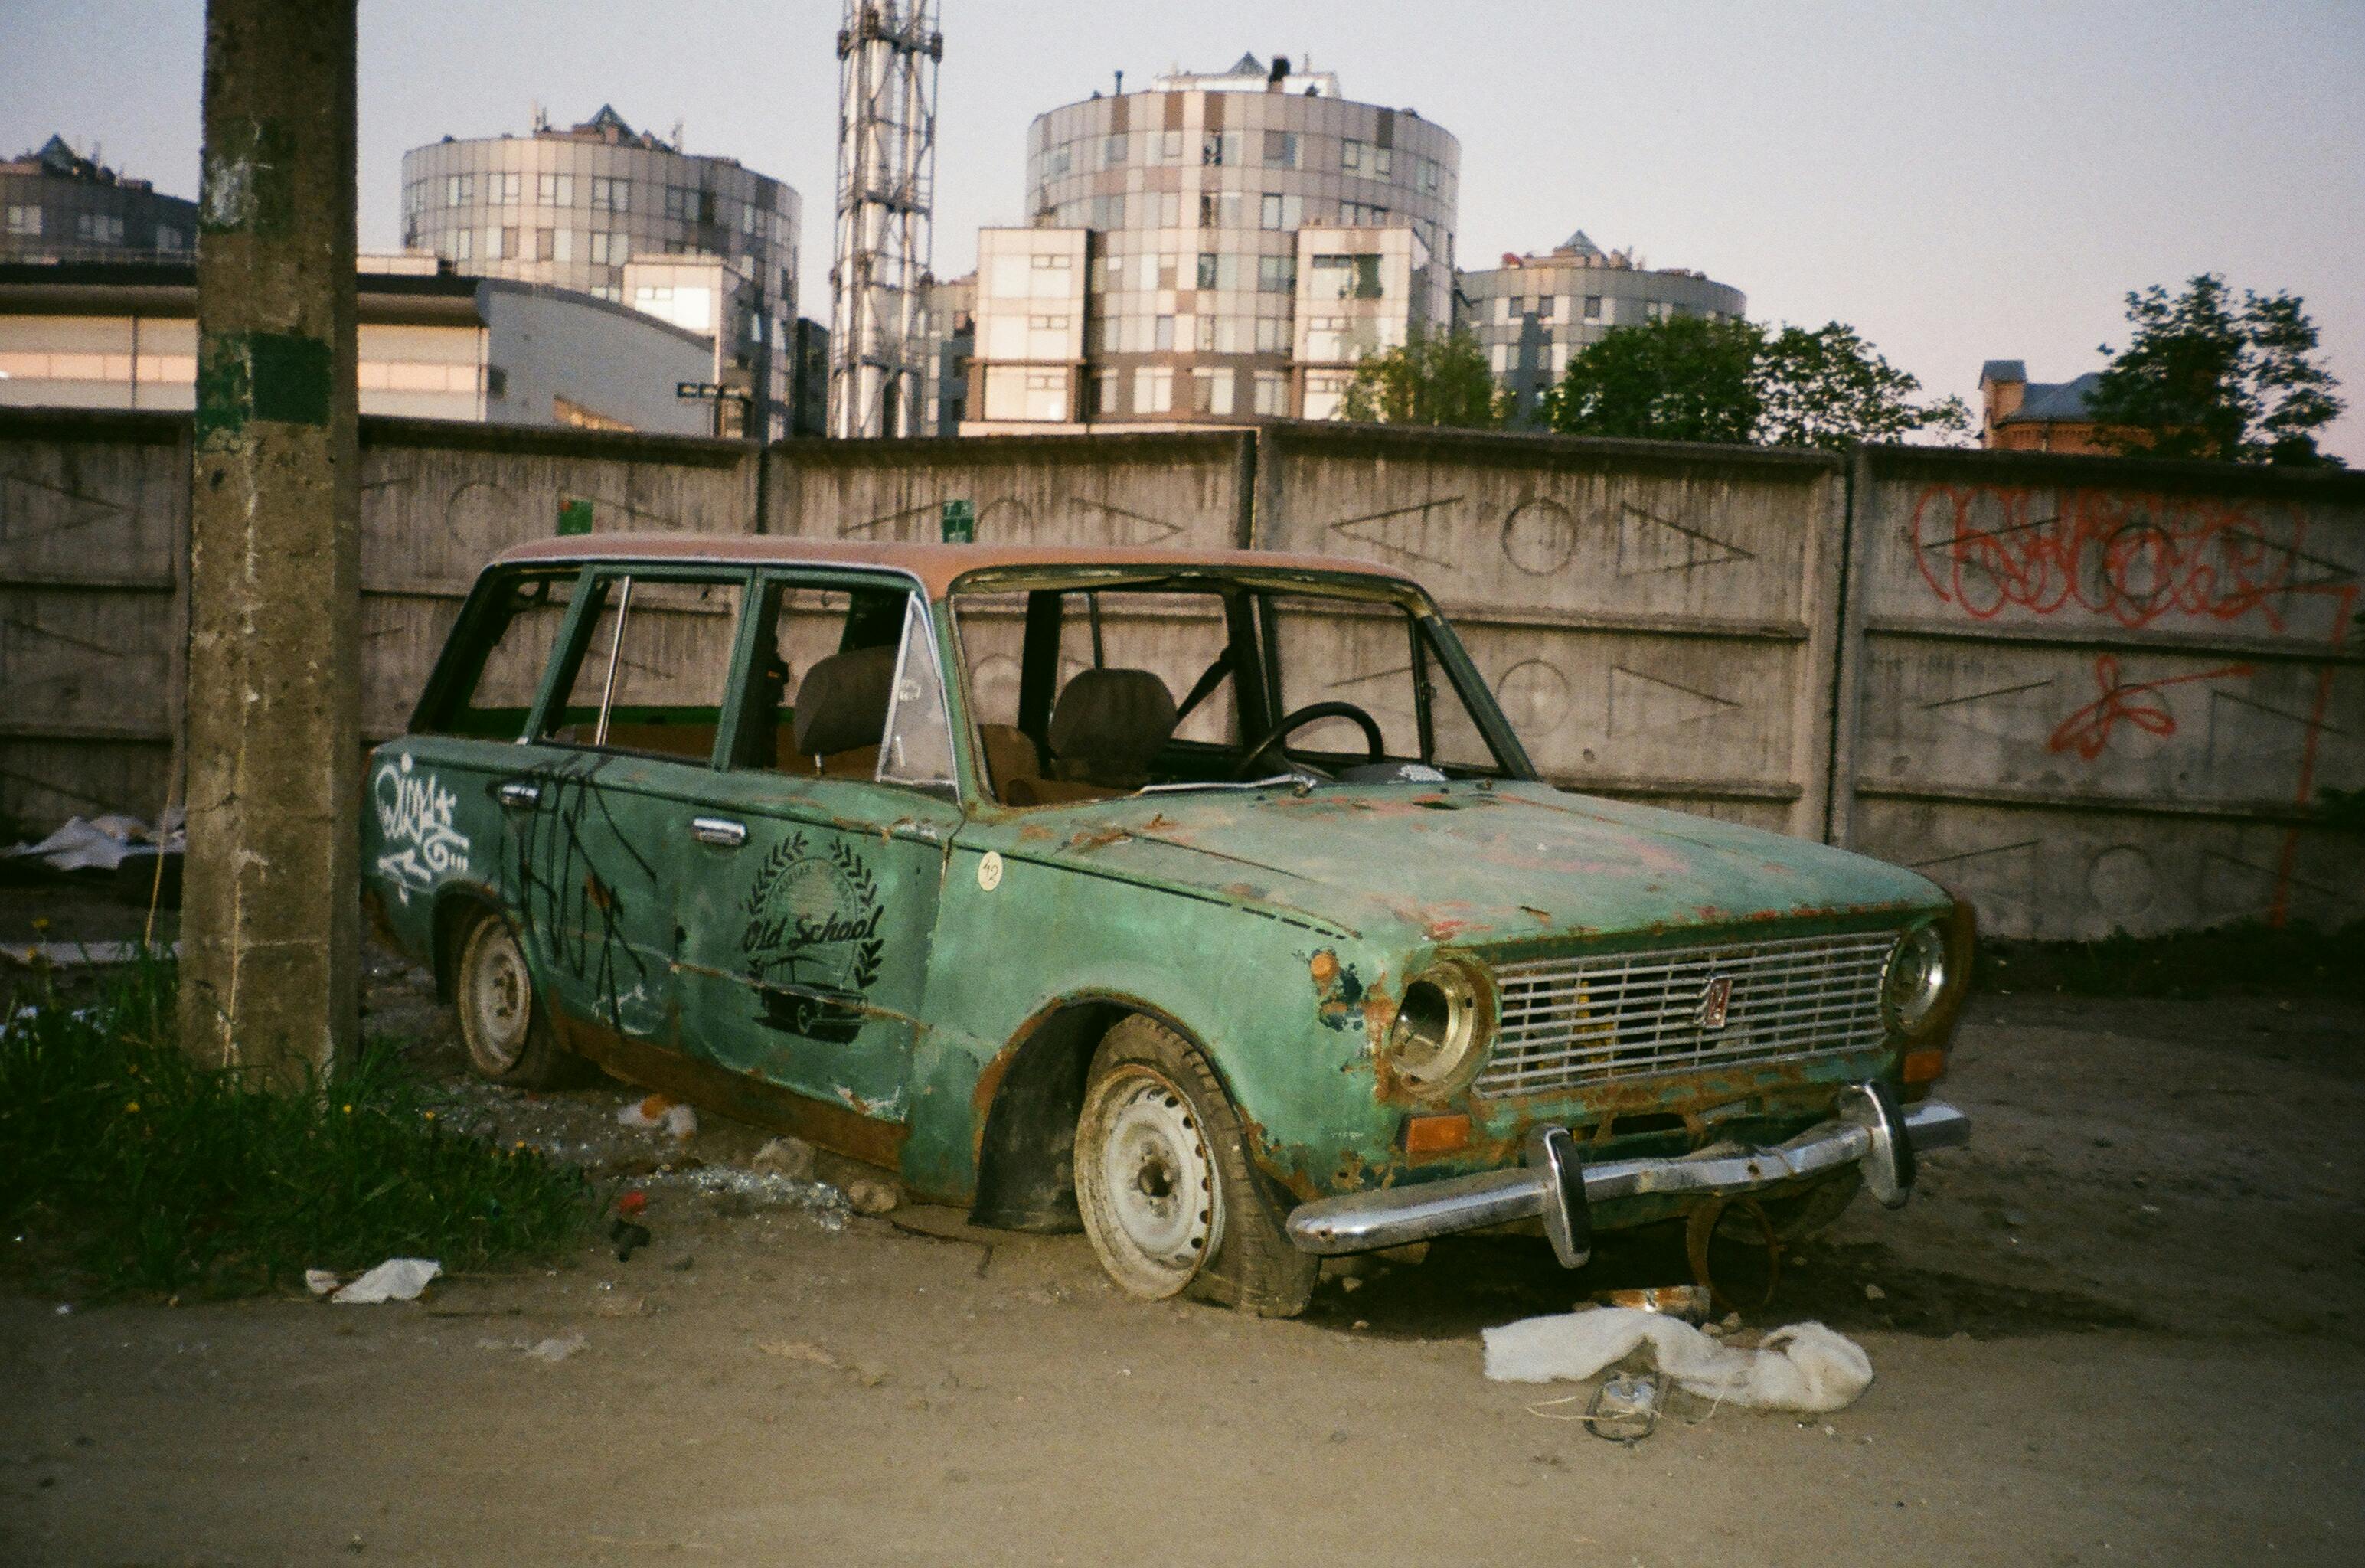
[495,534,1416,599]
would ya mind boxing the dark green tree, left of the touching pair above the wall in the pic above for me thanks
[1544,317,1764,443]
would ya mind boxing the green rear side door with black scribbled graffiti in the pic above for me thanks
[497,565,747,1057]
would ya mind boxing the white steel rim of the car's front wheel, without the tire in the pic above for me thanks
[1083,1069,1223,1301]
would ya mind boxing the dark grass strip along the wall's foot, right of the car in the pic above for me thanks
[1972,920,2365,998]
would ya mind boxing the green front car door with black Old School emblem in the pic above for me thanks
[676,573,962,1135]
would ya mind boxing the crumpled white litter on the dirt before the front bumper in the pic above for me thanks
[1481,1308,1873,1414]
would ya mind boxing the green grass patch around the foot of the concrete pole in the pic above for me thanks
[0,960,596,1296]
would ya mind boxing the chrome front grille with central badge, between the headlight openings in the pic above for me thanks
[1473,932,1896,1095]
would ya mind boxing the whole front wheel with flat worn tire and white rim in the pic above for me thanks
[1076,1014,1320,1318]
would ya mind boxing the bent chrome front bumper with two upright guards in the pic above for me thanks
[1289,1083,1970,1268]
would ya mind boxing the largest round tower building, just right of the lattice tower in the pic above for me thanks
[962,54,1462,430]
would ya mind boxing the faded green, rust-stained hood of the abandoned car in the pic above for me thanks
[1031,782,1946,946]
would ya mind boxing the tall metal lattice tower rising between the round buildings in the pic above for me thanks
[830,0,944,437]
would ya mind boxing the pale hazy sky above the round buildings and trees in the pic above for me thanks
[14,0,2365,466]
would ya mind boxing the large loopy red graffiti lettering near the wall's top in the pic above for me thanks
[1913,485,2318,632]
